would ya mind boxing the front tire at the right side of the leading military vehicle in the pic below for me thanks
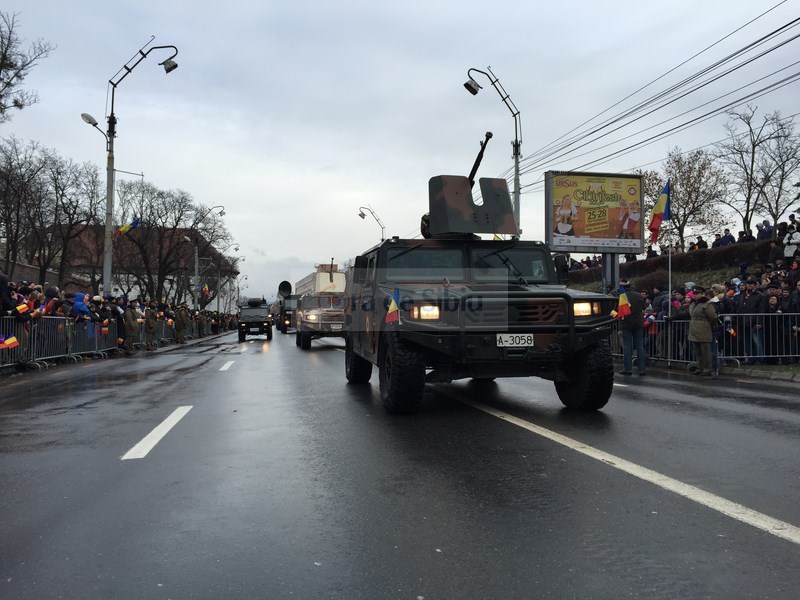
[555,340,614,410]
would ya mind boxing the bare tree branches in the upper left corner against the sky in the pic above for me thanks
[0,11,53,123]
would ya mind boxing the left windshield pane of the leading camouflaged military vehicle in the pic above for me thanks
[386,247,464,281]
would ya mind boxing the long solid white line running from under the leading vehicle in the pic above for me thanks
[461,399,800,544]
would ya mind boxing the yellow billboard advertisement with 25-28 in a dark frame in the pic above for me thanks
[545,171,644,254]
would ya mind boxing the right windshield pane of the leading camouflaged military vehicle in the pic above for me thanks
[470,246,550,283]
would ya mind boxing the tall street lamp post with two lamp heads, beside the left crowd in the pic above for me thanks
[81,37,178,294]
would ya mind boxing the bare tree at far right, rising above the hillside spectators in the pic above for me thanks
[716,106,787,231]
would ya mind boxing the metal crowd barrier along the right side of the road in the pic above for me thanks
[611,313,800,369]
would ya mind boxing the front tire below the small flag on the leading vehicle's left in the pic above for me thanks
[378,332,425,414]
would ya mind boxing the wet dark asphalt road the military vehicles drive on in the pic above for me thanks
[0,333,800,600]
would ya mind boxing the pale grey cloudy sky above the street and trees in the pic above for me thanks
[0,0,800,298]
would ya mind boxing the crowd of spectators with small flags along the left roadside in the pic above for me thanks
[0,271,237,355]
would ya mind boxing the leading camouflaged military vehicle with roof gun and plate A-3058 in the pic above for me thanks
[345,134,616,413]
